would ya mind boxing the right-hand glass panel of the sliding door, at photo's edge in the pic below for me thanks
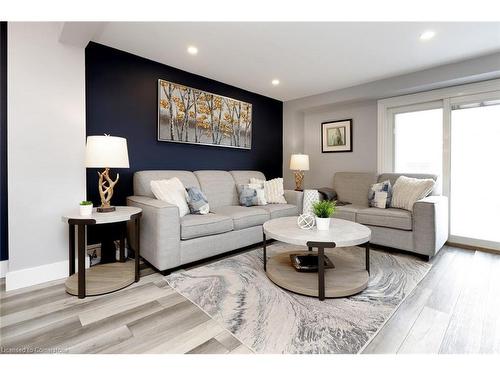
[449,97,500,248]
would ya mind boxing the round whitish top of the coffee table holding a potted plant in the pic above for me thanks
[263,216,371,247]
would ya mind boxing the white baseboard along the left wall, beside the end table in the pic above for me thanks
[2,257,90,291]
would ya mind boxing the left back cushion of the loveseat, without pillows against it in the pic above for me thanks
[333,172,377,207]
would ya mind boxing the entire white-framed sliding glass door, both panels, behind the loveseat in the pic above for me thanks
[386,91,500,250]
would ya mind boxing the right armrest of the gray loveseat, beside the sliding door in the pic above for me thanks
[413,195,448,256]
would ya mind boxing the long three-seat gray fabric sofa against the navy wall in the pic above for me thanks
[127,170,303,271]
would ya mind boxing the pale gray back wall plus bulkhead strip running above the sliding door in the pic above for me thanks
[283,53,500,189]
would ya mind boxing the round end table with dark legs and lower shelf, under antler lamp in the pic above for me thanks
[62,206,142,298]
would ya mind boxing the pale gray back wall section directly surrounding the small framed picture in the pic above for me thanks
[303,101,377,188]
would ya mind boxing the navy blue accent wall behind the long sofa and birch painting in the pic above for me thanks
[85,42,283,244]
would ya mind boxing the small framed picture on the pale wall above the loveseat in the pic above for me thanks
[321,119,352,152]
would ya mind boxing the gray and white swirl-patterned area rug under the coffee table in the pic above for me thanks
[165,242,431,354]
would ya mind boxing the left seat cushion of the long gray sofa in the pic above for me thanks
[181,213,233,240]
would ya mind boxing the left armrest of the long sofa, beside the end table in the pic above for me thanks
[127,195,181,271]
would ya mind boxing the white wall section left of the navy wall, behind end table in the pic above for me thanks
[6,22,86,290]
